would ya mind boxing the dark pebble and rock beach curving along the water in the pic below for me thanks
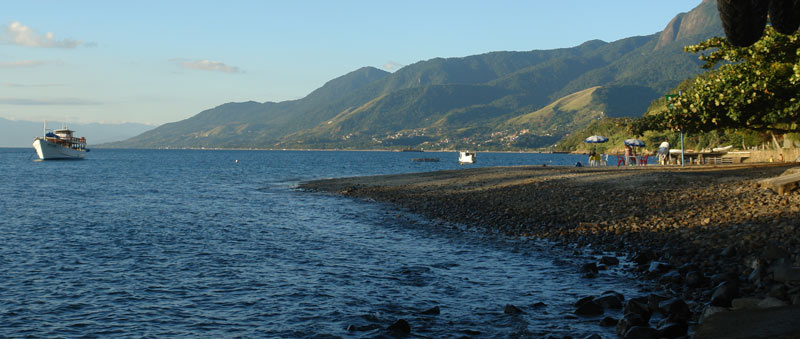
[300,164,800,338]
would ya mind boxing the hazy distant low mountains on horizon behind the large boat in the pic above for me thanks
[0,118,155,148]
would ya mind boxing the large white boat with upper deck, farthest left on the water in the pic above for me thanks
[33,122,89,160]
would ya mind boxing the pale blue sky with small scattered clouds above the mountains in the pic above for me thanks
[0,0,700,125]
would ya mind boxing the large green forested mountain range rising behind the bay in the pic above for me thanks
[104,0,723,149]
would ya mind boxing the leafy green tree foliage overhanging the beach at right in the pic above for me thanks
[632,27,800,134]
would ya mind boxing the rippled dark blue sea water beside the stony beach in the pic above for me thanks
[0,149,637,338]
